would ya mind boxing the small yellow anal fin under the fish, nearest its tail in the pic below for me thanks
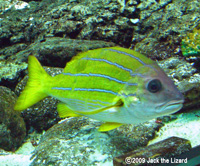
[57,103,81,118]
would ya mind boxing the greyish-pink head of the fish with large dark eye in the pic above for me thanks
[123,64,184,121]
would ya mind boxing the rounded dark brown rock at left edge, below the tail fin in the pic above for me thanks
[0,86,26,151]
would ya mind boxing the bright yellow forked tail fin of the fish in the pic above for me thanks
[14,56,51,111]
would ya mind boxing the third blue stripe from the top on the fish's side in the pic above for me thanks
[63,73,137,86]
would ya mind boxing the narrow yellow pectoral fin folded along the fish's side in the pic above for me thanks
[74,99,124,115]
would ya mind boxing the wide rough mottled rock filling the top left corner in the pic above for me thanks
[0,0,126,47]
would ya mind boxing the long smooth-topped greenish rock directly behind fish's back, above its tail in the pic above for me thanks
[10,37,115,68]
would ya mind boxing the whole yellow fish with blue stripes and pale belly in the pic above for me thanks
[14,47,184,132]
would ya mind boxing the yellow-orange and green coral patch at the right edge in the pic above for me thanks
[181,26,200,57]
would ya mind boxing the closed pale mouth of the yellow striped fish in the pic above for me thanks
[156,100,184,115]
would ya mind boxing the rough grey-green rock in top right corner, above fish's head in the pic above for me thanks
[131,0,200,59]
